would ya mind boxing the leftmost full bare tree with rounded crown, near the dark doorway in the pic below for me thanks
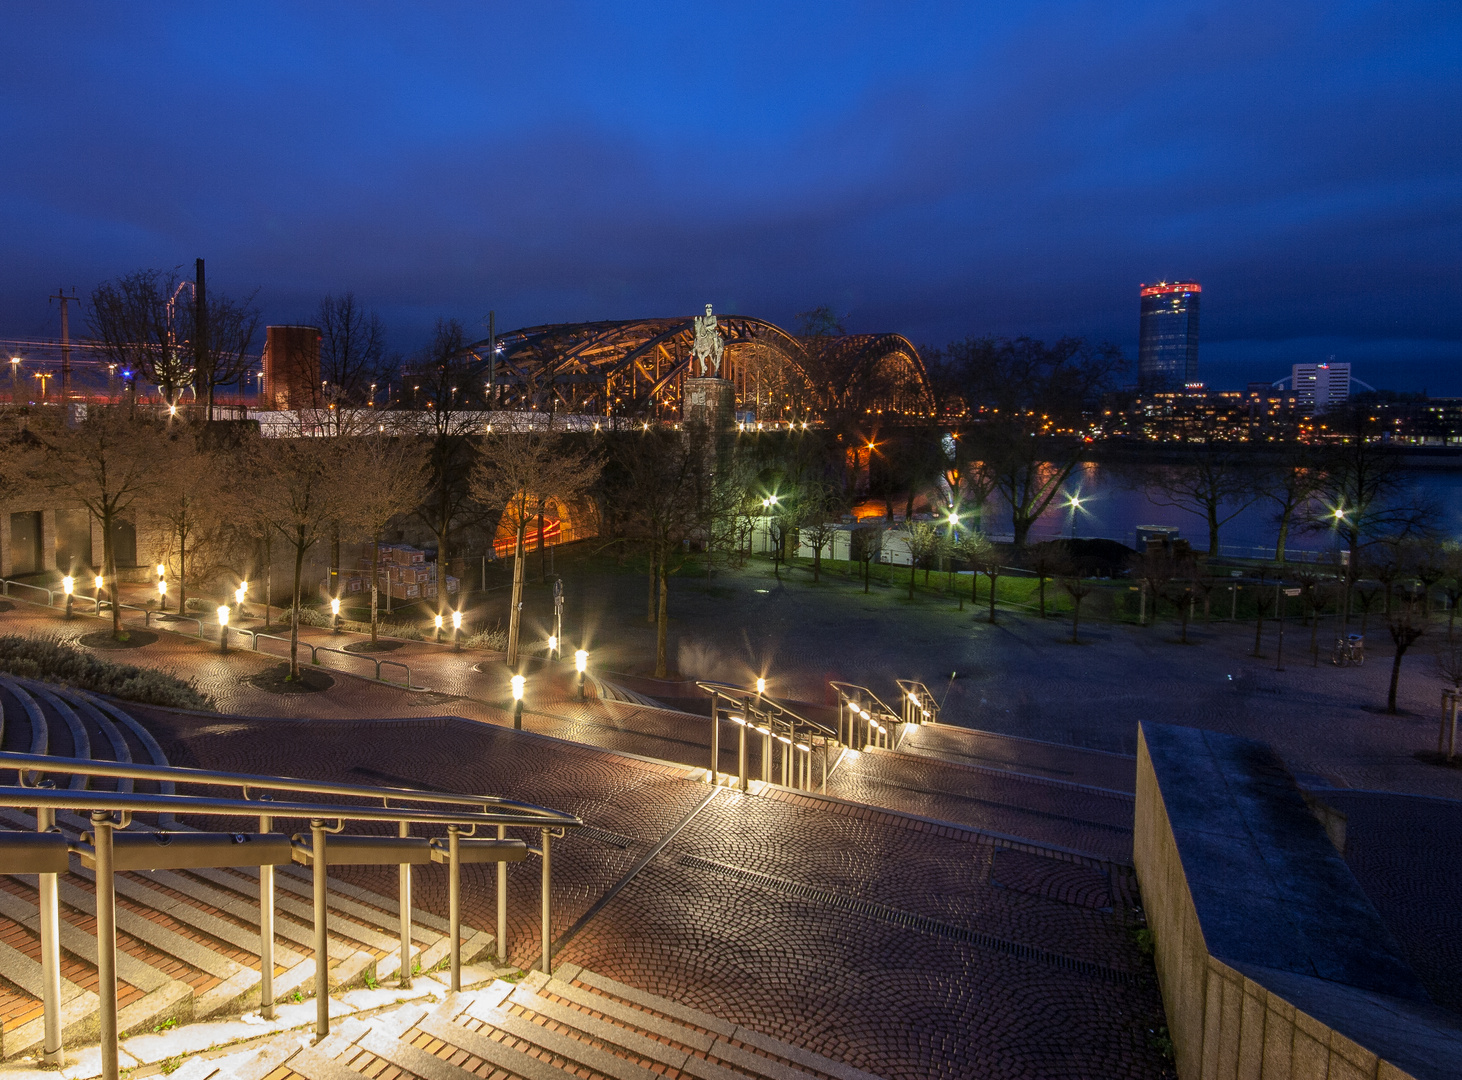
[31,406,167,642]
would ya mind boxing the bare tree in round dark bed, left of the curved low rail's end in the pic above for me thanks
[249,438,349,680]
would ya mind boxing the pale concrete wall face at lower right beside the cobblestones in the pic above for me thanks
[1133,731,1456,1080]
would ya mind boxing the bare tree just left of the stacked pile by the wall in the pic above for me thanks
[342,433,426,644]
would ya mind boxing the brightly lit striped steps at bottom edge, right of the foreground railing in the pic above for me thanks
[182,965,877,1080]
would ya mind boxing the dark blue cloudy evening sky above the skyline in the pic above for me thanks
[0,0,1462,393]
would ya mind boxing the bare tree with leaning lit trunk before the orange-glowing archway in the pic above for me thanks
[469,431,602,671]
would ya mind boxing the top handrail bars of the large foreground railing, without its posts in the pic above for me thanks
[0,753,583,829]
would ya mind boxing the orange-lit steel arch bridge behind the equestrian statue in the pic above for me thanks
[463,314,934,425]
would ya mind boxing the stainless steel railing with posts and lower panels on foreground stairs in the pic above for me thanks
[0,753,583,1080]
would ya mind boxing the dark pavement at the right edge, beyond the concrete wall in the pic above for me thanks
[1317,791,1462,1013]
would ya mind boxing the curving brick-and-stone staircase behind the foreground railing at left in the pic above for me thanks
[0,675,497,1060]
